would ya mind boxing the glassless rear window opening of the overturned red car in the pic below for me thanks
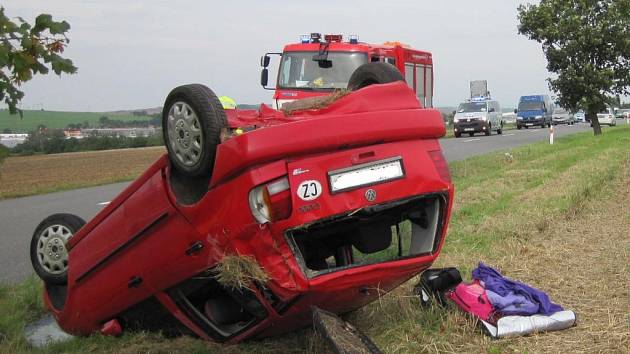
[287,197,443,277]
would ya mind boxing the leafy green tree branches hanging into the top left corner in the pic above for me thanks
[0,7,77,115]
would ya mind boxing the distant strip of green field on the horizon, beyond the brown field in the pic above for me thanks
[0,109,150,133]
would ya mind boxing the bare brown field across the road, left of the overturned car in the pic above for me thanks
[0,147,165,199]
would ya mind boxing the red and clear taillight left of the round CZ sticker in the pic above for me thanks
[249,177,291,224]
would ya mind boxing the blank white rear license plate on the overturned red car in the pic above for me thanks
[328,156,405,193]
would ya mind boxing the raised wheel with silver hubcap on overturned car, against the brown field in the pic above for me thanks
[162,84,227,177]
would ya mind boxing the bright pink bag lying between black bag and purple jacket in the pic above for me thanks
[446,281,494,321]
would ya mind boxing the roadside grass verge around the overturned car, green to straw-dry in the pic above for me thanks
[0,127,630,353]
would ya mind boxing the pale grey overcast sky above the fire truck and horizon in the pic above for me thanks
[2,0,548,111]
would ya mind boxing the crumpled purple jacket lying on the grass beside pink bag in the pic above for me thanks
[472,262,563,316]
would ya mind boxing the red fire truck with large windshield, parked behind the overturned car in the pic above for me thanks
[260,33,433,109]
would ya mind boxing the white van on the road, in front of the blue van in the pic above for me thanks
[453,97,503,138]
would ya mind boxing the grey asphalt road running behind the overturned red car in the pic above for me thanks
[0,124,591,283]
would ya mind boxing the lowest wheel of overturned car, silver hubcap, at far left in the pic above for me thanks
[30,214,85,285]
